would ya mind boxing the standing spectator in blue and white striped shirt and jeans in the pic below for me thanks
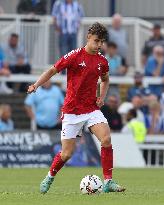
[52,0,84,56]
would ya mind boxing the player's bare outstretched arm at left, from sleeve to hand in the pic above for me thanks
[27,66,58,93]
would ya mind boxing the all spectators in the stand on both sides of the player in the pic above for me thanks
[0,7,164,143]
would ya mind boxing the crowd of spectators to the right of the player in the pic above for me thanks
[102,14,164,143]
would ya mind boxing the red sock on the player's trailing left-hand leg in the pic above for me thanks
[50,152,65,176]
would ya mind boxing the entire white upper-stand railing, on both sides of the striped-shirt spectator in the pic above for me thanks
[0,14,157,70]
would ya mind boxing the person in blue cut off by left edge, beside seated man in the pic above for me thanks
[0,47,13,94]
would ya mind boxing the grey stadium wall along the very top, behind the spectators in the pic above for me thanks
[0,0,164,18]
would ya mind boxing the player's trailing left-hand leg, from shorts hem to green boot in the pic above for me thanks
[40,139,76,194]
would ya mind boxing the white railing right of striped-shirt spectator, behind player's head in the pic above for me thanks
[78,17,153,70]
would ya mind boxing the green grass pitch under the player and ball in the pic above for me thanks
[0,168,164,205]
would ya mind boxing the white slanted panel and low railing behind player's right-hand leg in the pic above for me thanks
[92,133,164,168]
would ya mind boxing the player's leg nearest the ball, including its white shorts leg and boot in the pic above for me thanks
[87,110,125,192]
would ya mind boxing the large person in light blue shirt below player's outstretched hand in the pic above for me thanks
[25,81,64,129]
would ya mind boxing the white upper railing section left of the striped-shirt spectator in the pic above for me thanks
[0,14,52,70]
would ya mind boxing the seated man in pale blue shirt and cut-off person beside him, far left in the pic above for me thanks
[0,33,31,94]
